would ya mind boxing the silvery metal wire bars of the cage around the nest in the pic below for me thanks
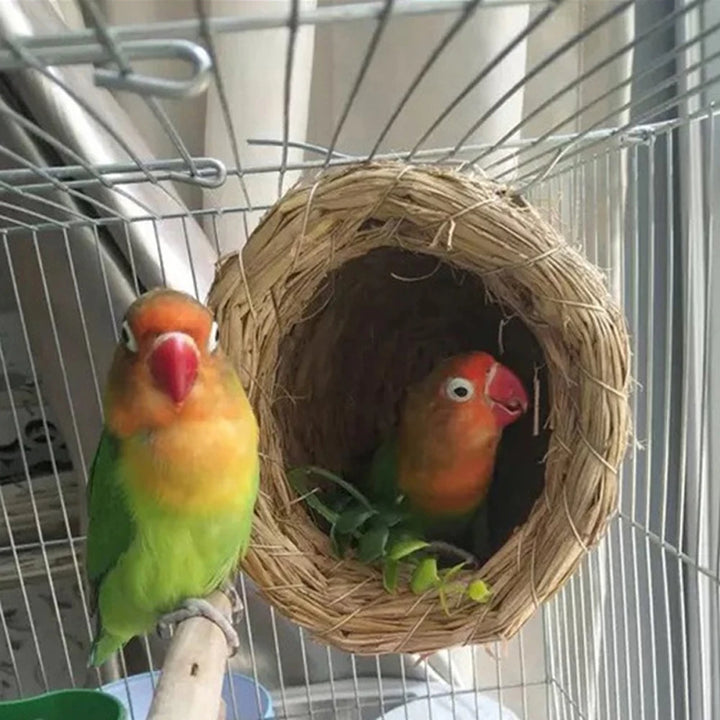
[0,0,720,720]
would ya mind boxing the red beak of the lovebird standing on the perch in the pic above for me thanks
[149,332,199,404]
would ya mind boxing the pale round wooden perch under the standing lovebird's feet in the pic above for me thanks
[148,591,230,720]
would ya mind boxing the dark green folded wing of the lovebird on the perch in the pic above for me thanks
[85,430,135,606]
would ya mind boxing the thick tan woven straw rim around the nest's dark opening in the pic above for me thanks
[208,162,630,654]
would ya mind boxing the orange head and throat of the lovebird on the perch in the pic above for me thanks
[105,288,244,436]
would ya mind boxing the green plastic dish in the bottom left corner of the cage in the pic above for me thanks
[0,690,127,720]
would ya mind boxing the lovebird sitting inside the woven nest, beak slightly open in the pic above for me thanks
[366,352,528,556]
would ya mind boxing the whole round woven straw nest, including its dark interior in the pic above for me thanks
[210,163,629,654]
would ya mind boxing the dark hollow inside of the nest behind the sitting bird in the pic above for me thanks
[274,247,549,561]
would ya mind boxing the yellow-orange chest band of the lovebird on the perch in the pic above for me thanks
[122,418,258,513]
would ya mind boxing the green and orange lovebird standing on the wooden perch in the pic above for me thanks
[86,289,259,666]
